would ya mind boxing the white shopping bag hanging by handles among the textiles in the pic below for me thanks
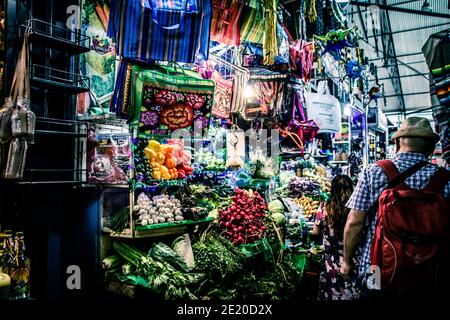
[306,81,341,133]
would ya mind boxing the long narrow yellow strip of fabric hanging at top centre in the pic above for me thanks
[263,0,278,65]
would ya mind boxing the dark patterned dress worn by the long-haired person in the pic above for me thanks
[318,220,359,300]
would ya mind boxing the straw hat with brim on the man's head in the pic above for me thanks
[392,117,440,143]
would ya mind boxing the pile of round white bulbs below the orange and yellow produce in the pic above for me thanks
[133,193,184,226]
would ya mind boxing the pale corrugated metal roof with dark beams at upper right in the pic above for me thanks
[347,0,450,119]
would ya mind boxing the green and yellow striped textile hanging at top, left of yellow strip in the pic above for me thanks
[241,0,264,44]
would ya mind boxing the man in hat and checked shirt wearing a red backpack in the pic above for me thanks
[340,117,450,299]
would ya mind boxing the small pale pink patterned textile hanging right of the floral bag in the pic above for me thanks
[211,71,233,119]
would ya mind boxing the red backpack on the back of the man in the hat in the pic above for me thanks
[371,160,450,290]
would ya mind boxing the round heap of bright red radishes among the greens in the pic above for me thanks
[219,189,267,244]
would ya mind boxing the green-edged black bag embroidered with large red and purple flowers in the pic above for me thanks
[131,66,214,136]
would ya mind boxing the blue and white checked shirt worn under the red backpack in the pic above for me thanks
[347,153,450,277]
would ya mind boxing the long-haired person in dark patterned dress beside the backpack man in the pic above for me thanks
[313,175,359,300]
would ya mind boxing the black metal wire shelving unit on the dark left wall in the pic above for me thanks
[7,19,91,186]
